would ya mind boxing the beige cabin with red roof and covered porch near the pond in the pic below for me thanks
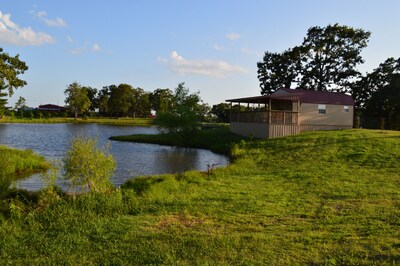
[226,88,354,138]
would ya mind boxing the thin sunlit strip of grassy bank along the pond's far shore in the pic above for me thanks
[0,117,154,126]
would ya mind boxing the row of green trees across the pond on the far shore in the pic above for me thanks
[64,82,210,120]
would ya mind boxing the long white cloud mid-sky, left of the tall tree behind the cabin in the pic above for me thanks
[165,51,247,78]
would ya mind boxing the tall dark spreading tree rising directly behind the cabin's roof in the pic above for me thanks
[257,24,370,94]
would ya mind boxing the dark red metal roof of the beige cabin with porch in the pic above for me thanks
[226,88,354,105]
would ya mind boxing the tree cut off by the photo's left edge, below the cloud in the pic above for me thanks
[0,48,28,116]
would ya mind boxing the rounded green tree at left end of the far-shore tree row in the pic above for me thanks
[64,82,90,119]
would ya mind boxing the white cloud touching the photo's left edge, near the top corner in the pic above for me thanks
[0,11,55,46]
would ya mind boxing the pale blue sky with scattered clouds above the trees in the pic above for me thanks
[0,0,400,107]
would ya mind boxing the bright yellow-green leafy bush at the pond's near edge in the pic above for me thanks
[64,136,115,192]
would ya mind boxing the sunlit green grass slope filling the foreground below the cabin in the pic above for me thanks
[0,130,400,265]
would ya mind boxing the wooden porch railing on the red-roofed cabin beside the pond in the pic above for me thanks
[230,110,299,125]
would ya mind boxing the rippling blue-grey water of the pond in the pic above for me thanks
[0,124,229,191]
